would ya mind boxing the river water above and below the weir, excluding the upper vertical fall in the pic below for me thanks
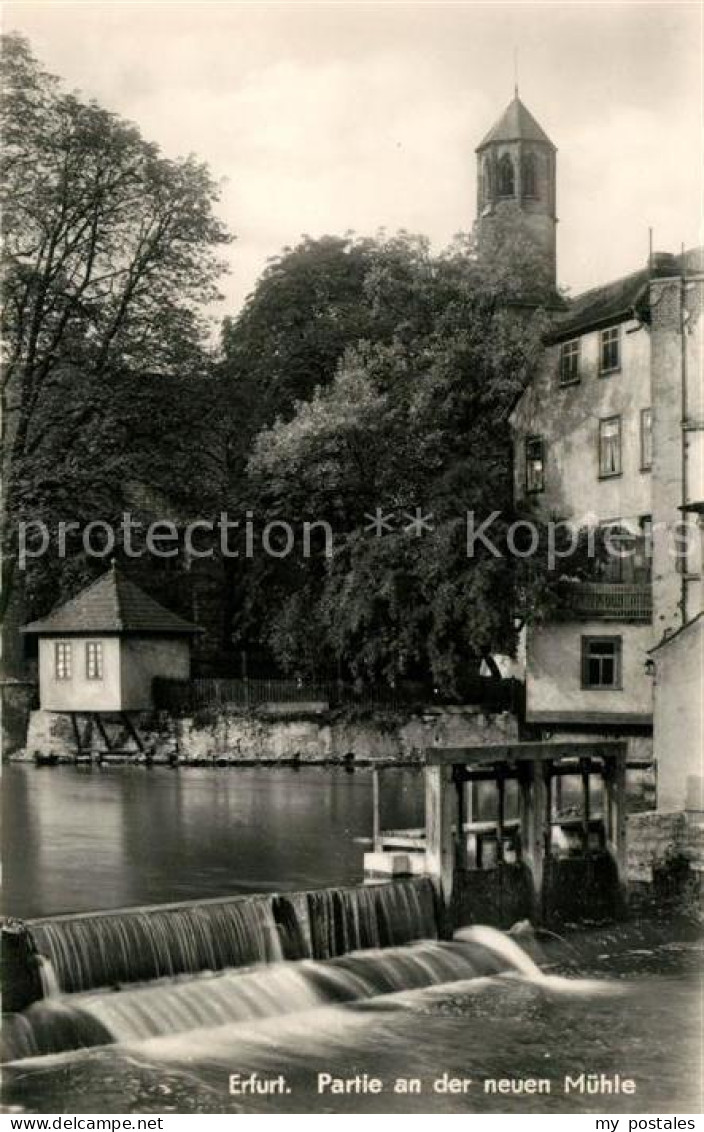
[2,766,702,1115]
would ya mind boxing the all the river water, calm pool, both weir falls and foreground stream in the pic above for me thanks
[3,767,702,1114]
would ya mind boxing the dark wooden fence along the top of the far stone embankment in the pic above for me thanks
[154,676,523,714]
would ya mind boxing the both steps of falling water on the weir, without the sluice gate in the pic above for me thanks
[5,877,588,1060]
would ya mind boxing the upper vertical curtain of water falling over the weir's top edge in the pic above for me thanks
[27,877,437,994]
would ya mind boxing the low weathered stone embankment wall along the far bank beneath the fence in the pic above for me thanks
[23,706,517,764]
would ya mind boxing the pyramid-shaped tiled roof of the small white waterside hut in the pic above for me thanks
[22,565,200,636]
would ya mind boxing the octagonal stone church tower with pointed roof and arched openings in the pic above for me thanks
[477,87,557,291]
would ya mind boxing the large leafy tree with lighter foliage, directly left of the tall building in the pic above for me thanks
[244,238,552,694]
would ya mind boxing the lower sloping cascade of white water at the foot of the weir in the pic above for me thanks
[5,941,525,1060]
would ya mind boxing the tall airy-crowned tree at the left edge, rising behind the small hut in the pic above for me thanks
[0,35,230,642]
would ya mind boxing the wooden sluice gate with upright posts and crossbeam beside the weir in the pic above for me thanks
[364,740,627,932]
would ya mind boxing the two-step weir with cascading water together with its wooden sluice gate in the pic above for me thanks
[2,743,626,1060]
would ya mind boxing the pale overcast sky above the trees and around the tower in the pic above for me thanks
[3,0,703,312]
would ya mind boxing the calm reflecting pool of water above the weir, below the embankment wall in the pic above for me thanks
[2,764,422,917]
